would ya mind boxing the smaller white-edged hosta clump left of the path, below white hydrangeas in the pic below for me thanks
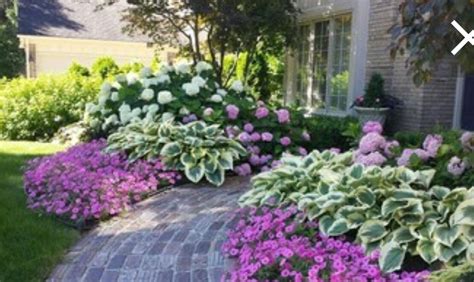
[159,122,247,186]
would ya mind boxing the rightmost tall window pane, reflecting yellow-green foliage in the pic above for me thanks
[329,15,352,111]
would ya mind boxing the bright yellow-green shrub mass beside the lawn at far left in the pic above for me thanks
[0,75,100,140]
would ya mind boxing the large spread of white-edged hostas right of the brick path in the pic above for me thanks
[241,151,474,272]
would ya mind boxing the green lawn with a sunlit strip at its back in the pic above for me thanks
[0,141,79,282]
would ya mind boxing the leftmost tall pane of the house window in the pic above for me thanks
[296,25,310,105]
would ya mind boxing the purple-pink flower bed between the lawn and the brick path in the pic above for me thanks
[24,140,180,221]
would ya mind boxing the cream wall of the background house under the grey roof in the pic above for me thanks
[20,36,174,77]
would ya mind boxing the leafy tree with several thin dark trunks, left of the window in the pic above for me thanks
[109,0,298,85]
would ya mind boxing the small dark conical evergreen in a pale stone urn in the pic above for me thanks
[352,73,396,125]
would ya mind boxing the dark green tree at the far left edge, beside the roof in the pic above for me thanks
[0,0,24,78]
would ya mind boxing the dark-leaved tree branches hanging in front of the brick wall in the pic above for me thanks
[390,0,474,85]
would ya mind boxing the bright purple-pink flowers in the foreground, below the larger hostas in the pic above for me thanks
[223,207,429,282]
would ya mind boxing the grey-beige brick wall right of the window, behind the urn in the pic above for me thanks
[366,0,457,131]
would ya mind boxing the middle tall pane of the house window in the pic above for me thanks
[312,21,329,108]
